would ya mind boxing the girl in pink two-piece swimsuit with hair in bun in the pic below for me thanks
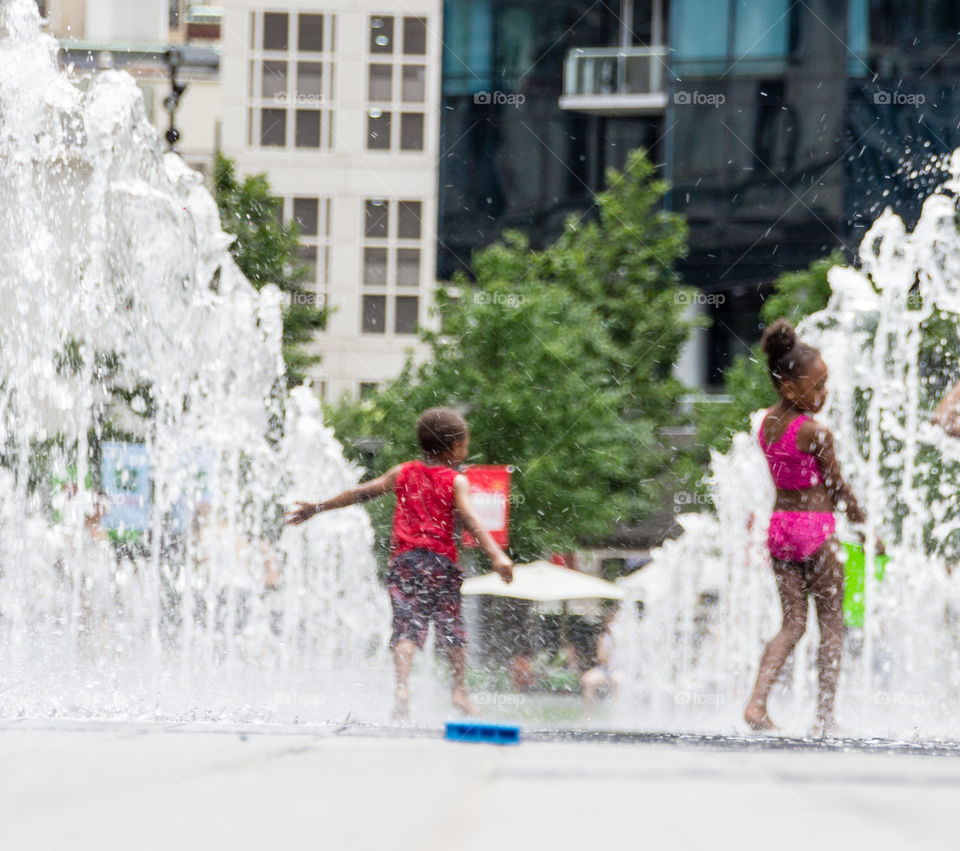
[744,319,864,736]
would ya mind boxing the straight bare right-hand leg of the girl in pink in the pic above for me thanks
[810,541,843,736]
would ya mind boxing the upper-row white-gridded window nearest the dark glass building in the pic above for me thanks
[367,15,427,152]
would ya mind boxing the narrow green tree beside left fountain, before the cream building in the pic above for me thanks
[213,154,329,386]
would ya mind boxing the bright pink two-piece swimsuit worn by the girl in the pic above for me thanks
[759,413,836,561]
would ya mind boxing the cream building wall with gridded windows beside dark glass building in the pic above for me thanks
[221,0,442,400]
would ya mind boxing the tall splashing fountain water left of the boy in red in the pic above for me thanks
[0,0,388,720]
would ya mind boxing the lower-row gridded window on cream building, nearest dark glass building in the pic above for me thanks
[361,198,424,334]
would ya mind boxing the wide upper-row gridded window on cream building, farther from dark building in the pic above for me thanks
[247,12,336,151]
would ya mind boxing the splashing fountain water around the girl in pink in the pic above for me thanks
[621,158,960,738]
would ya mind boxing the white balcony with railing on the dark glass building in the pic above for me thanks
[560,46,667,115]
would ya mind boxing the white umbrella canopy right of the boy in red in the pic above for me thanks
[460,561,625,602]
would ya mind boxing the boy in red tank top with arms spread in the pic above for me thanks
[286,408,513,718]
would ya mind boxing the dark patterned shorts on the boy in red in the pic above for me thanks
[387,549,467,649]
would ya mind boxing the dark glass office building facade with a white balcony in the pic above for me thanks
[439,0,960,387]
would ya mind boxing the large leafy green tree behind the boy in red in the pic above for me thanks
[330,153,690,559]
